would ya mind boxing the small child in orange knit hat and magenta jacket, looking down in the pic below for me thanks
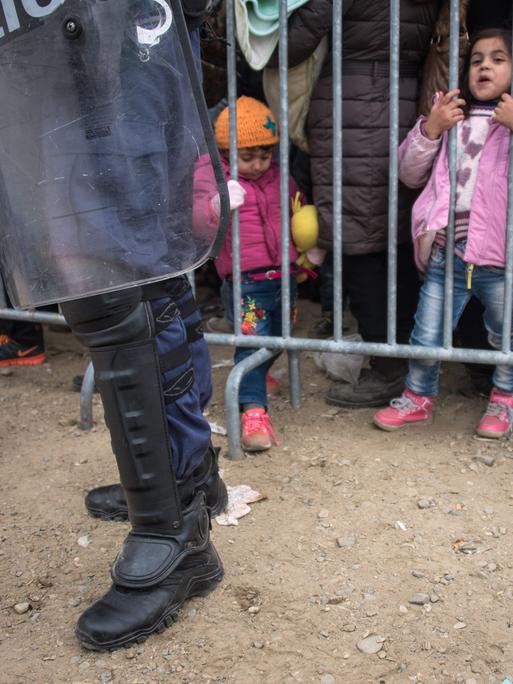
[211,97,306,451]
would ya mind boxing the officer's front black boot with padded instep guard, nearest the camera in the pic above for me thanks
[75,492,224,651]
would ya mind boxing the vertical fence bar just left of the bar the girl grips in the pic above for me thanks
[387,0,400,344]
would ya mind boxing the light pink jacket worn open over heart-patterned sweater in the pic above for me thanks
[399,117,510,271]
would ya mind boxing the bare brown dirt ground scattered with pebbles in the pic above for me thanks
[0,302,513,684]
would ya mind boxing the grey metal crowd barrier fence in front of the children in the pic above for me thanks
[0,0,513,459]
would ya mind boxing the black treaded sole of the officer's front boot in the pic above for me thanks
[75,561,224,651]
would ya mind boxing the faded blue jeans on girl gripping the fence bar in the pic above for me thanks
[406,243,513,396]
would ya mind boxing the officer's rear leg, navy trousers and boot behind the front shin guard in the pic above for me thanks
[85,276,228,520]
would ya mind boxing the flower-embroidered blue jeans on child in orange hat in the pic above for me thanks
[224,275,296,408]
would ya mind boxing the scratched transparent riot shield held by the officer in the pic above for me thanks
[0,0,228,307]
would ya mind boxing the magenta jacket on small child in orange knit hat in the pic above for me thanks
[215,158,304,278]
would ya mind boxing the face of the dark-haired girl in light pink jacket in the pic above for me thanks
[468,37,511,102]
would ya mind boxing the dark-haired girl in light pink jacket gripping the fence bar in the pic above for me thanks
[374,29,513,438]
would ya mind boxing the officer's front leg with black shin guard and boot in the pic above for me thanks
[62,288,223,649]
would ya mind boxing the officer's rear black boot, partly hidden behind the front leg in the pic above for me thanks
[85,445,228,521]
